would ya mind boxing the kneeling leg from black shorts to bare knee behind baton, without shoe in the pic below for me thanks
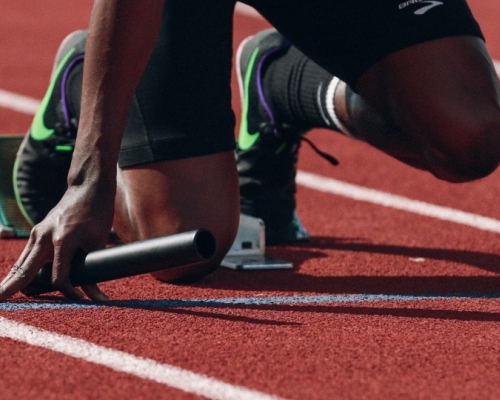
[114,0,239,281]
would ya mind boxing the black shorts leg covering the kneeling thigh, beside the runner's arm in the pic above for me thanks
[119,0,239,167]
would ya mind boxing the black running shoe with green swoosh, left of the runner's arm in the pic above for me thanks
[13,31,87,225]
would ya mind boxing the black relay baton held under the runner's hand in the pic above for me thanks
[22,229,217,296]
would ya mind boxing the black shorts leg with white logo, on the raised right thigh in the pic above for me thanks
[248,0,482,89]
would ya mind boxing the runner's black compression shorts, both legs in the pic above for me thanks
[119,0,482,167]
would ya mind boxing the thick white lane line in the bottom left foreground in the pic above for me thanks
[0,317,279,400]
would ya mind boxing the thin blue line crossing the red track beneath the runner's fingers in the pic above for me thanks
[0,292,500,311]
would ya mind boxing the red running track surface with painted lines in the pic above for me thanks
[0,0,500,399]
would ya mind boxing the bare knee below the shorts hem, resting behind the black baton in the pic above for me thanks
[113,151,239,280]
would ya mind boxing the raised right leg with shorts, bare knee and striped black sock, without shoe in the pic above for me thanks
[245,1,500,182]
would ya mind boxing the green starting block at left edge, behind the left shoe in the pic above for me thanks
[0,135,31,239]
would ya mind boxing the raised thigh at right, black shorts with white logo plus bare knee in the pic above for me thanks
[250,0,500,181]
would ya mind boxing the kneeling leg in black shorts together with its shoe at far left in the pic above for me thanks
[16,0,239,281]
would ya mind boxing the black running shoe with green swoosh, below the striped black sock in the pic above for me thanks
[236,29,310,245]
